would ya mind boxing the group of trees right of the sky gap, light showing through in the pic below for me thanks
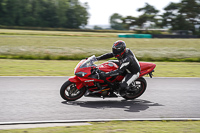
[110,0,200,35]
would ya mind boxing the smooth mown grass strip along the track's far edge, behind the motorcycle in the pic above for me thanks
[0,59,200,77]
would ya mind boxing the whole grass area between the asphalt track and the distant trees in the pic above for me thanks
[0,29,200,77]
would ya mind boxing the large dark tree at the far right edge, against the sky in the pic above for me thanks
[162,0,200,34]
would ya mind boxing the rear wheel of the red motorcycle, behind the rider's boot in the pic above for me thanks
[123,77,147,100]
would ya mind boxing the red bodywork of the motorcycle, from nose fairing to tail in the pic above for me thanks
[69,57,156,89]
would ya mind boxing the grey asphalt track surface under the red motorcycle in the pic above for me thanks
[0,77,200,123]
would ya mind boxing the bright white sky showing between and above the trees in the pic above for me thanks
[79,0,181,25]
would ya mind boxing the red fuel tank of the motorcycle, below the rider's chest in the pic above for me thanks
[98,62,118,72]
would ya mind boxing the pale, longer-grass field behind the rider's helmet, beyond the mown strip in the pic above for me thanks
[0,29,200,62]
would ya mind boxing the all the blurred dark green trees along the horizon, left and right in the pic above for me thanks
[0,0,200,35]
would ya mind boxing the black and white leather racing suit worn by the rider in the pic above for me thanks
[97,48,140,89]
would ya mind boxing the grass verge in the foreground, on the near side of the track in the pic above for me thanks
[0,121,200,133]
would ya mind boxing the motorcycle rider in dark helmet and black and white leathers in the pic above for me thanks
[97,40,140,95]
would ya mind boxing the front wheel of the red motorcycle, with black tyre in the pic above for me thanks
[60,80,86,101]
